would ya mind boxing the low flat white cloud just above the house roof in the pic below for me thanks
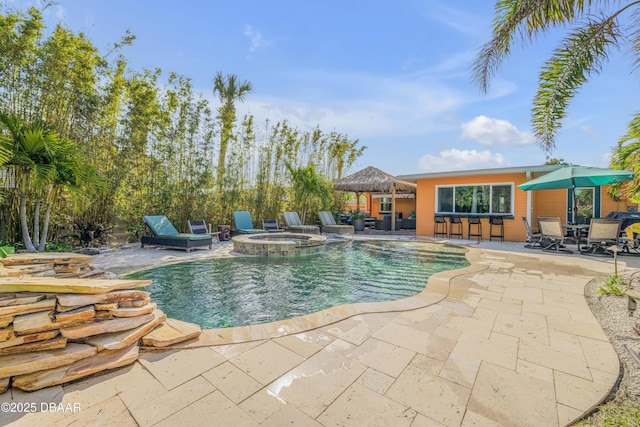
[419,148,509,172]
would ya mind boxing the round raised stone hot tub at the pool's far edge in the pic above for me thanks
[232,233,327,256]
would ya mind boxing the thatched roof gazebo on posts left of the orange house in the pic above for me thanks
[333,166,417,231]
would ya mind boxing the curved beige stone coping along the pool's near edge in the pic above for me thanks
[142,242,488,351]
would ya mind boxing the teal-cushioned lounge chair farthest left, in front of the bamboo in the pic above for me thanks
[140,215,213,252]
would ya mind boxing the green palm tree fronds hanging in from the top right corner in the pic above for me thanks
[472,0,640,201]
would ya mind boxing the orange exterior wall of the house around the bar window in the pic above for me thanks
[416,172,631,242]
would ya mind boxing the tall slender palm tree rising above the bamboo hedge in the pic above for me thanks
[213,72,252,194]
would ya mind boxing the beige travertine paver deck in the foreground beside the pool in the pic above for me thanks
[0,244,625,426]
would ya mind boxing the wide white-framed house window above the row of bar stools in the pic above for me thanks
[436,184,513,215]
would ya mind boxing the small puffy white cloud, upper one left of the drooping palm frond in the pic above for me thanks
[460,116,535,147]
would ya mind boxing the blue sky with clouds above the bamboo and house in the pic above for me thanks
[13,0,639,174]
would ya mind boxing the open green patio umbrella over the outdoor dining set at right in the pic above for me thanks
[518,165,633,222]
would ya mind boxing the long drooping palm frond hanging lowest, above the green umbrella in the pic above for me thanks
[532,17,619,152]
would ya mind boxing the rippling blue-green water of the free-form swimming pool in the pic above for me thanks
[127,240,468,328]
